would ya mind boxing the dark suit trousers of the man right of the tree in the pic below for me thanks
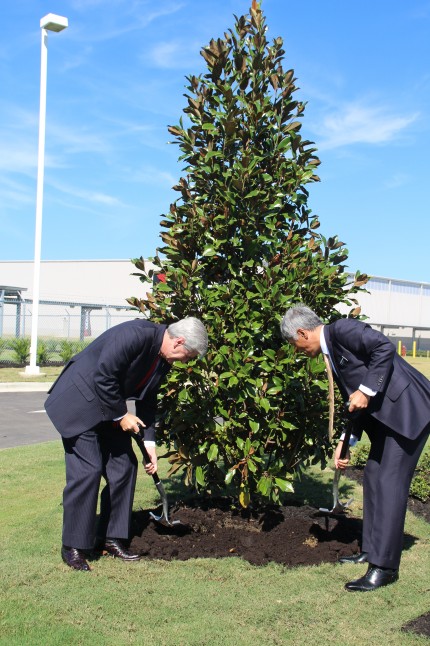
[362,420,430,569]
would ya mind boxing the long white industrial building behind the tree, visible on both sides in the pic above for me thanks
[0,260,430,350]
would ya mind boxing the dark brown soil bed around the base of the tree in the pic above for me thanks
[131,499,362,566]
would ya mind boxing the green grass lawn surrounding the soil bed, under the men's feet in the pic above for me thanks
[0,442,430,646]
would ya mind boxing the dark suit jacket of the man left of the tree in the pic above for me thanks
[45,319,170,440]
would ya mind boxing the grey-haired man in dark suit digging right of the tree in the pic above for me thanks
[281,305,430,592]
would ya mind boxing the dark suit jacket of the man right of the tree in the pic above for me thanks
[324,319,430,440]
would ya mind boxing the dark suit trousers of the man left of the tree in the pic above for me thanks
[63,423,137,550]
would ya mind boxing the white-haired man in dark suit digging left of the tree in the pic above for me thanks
[45,317,208,571]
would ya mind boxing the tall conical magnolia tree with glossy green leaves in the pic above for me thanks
[129,2,366,506]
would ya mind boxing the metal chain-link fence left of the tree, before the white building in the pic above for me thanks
[0,298,141,365]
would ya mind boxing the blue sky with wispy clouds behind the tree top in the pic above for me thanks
[0,0,430,282]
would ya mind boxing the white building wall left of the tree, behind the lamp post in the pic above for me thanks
[0,260,152,339]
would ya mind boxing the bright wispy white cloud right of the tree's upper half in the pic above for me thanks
[313,103,418,150]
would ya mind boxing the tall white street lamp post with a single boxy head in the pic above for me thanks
[25,13,69,375]
